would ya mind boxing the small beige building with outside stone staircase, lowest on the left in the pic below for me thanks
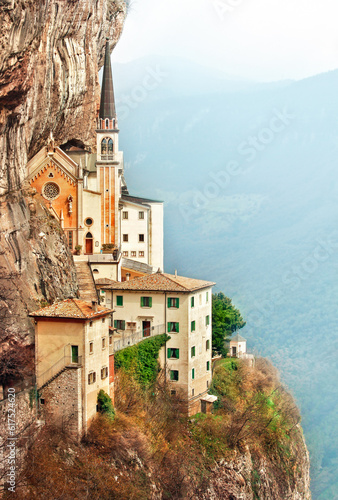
[30,299,114,435]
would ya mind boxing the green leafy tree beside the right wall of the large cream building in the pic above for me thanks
[212,292,246,356]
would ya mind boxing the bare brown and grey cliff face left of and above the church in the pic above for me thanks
[0,0,125,341]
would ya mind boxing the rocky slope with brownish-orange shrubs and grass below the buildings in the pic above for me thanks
[9,360,309,500]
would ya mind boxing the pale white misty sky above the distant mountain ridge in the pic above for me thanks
[113,0,338,81]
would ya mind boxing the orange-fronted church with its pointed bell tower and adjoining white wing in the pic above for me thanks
[27,41,163,279]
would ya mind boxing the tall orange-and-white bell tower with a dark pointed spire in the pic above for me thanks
[96,39,123,246]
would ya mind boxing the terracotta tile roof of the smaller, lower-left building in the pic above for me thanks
[30,299,112,319]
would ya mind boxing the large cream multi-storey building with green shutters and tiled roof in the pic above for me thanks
[97,272,215,414]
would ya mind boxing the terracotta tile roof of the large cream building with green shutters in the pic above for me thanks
[98,273,215,292]
